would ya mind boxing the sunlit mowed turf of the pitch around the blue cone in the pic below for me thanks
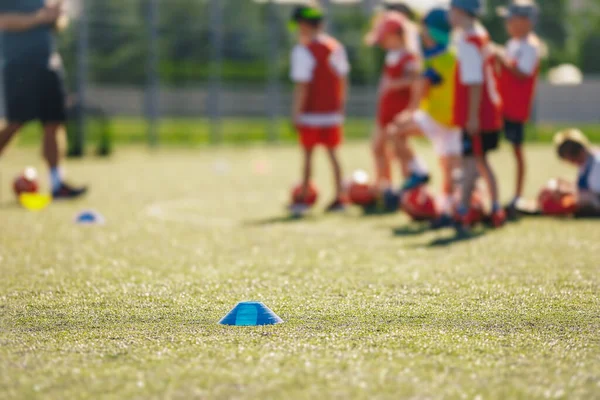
[0,142,600,399]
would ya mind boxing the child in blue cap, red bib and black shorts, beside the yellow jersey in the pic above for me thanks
[450,0,506,232]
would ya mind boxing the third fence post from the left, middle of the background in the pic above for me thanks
[207,0,224,144]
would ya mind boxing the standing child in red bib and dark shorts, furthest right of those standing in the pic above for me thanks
[497,0,541,212]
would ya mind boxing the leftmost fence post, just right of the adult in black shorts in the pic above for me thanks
[71,0,90,157]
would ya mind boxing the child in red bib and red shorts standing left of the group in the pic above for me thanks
[290,6,350,212]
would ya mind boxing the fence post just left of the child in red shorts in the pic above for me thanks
[265,0,280,142]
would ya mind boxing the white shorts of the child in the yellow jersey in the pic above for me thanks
[414,110,462,156]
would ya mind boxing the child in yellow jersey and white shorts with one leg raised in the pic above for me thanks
[388,8,462,225]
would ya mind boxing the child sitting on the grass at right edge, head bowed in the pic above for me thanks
[554,129,600,213]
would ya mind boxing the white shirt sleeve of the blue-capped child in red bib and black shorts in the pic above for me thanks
[456,26,487,85]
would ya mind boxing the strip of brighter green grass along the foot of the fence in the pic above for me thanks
[11,118,600,146]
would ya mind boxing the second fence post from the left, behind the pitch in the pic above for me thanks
[145,0,160,147]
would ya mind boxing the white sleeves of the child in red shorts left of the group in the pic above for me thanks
[290,38,350,83]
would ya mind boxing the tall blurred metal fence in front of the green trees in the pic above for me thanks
[1,0,600,145]
